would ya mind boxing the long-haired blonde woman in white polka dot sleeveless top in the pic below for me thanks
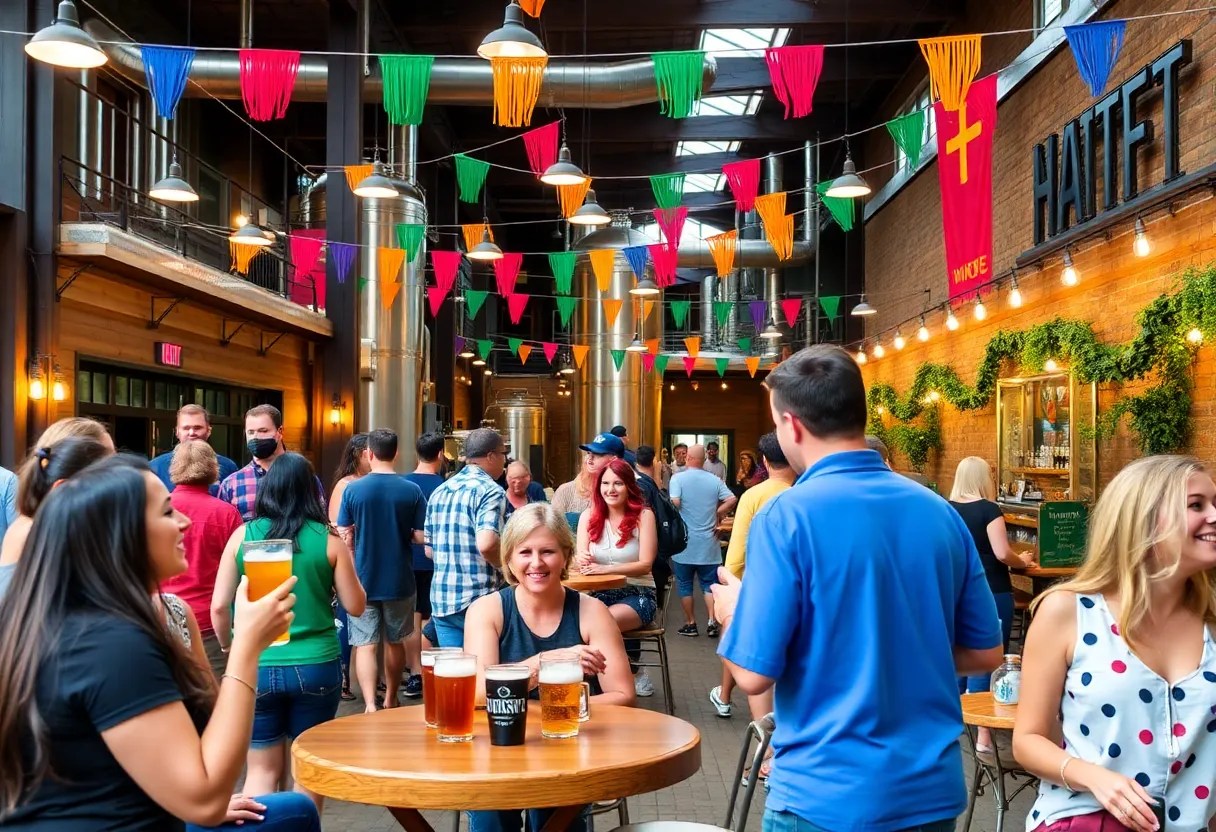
[1013,456,1216,832]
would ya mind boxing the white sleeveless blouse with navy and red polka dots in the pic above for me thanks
[1026,595,1216,832]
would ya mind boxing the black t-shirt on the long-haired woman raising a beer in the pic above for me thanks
[0,611,196,832]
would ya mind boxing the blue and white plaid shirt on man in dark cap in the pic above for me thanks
[426,465,507,615]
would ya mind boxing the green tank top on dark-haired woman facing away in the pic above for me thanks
[236,519,339,668]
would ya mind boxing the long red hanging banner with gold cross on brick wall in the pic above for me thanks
[933,75,996,300]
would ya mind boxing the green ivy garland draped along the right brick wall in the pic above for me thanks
[868,264,1216,472]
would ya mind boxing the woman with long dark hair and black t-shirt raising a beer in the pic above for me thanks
[0,457,302,831]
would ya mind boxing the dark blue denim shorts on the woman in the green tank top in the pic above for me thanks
[249,659,342,748]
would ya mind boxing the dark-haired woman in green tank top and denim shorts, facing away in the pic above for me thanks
[212,454,367,810]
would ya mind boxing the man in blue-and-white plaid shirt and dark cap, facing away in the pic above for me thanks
[426,428,507,647]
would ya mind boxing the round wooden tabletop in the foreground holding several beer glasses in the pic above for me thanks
[292,702,700,809]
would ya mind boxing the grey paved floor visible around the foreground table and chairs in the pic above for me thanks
[323,598,1034,832]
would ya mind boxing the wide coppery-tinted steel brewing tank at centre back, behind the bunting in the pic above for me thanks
[570,224,663,471]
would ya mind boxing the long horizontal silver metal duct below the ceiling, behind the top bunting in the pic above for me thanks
[84,20,717,109]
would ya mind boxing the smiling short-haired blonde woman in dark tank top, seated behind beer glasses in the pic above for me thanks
[462,502,635,832]
